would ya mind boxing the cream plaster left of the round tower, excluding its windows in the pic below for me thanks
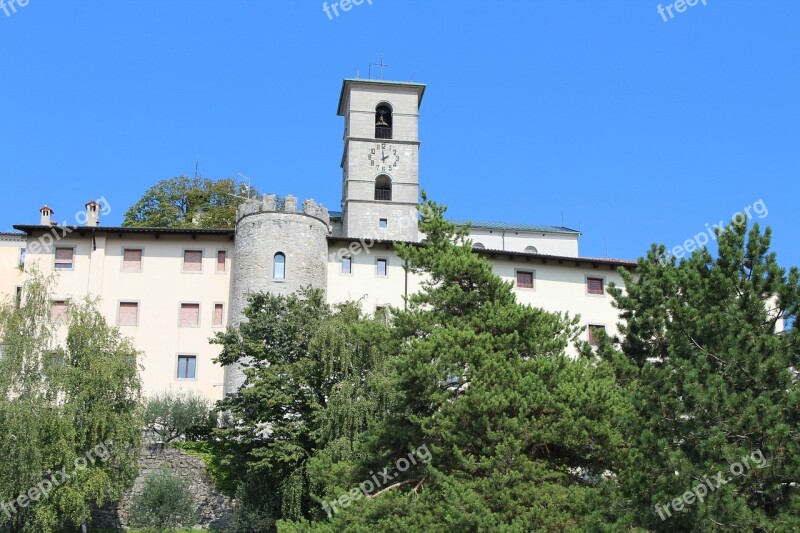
[21,232,233,400]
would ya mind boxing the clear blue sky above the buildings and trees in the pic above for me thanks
[0,0,800,266]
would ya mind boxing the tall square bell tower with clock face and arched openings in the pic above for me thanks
[338,79,425,242]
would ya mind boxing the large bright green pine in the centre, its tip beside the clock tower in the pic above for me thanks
[296,196,629,531]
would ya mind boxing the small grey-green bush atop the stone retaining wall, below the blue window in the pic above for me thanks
[144,391,214,442]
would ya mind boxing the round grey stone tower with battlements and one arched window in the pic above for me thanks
[224,194,330,395]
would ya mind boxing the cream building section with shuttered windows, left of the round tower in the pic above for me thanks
[17,226,233,399]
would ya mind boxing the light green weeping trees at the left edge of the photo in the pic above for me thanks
[0,270,142,532]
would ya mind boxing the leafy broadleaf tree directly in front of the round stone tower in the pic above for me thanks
[209,290,387,530]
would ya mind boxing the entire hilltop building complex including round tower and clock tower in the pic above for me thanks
[0,79,636,400]
